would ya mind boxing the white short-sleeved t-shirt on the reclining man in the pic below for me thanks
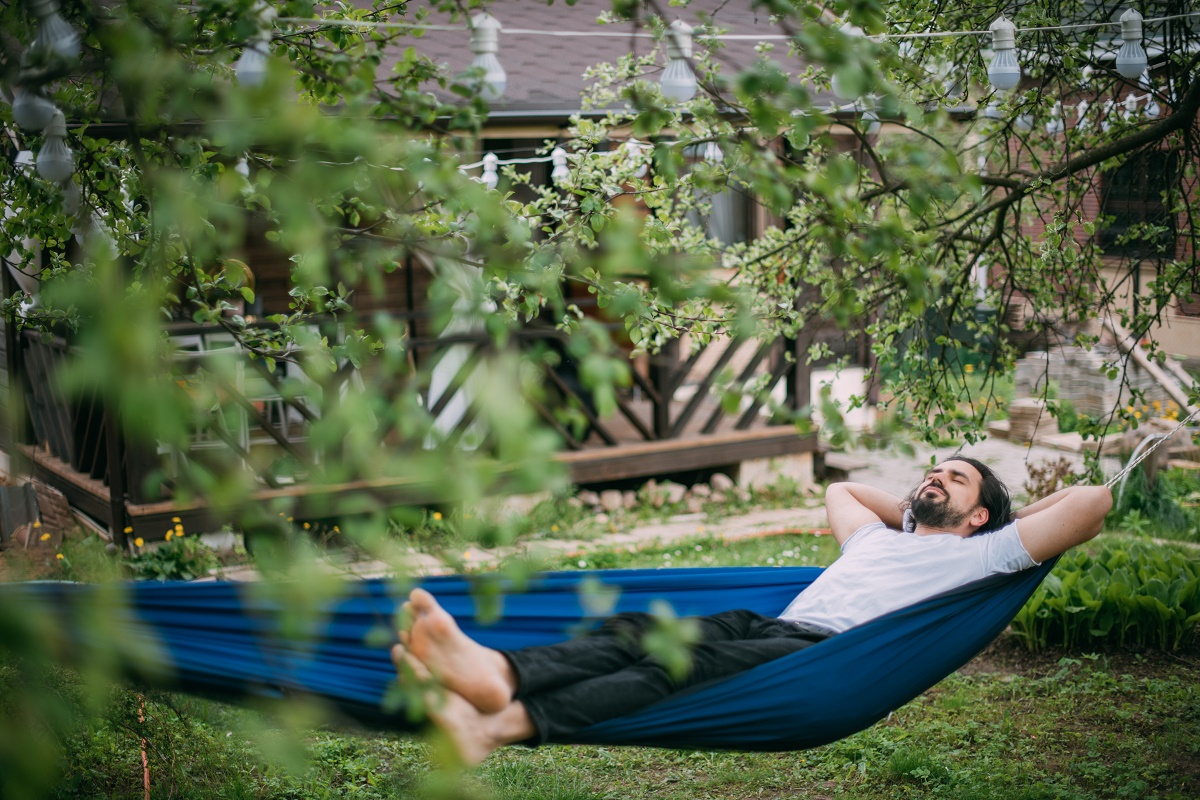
[779,521,1038,633]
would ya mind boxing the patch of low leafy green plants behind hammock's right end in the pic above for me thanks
[1013,541,1200,650]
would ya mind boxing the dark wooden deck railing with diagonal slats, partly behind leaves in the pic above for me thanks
[19,314,809,544]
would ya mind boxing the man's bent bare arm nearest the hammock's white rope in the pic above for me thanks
[1015,486,1112,561]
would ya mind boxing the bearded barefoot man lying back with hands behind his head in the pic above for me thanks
[392,457,1112,763]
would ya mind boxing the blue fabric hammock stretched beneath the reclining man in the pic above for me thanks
[11,563,1052,751]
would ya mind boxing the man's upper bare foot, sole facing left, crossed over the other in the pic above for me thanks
[401,589,516,714]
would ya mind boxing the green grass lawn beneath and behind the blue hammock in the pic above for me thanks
[11,527,1200,800]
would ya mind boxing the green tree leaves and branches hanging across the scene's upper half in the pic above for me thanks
[0,0,1200,798]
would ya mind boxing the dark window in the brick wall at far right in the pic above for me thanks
[1097,150,1177,259]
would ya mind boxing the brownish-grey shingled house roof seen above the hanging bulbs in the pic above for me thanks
[393,0,835,119]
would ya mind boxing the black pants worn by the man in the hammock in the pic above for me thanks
[504,610,833,744]
